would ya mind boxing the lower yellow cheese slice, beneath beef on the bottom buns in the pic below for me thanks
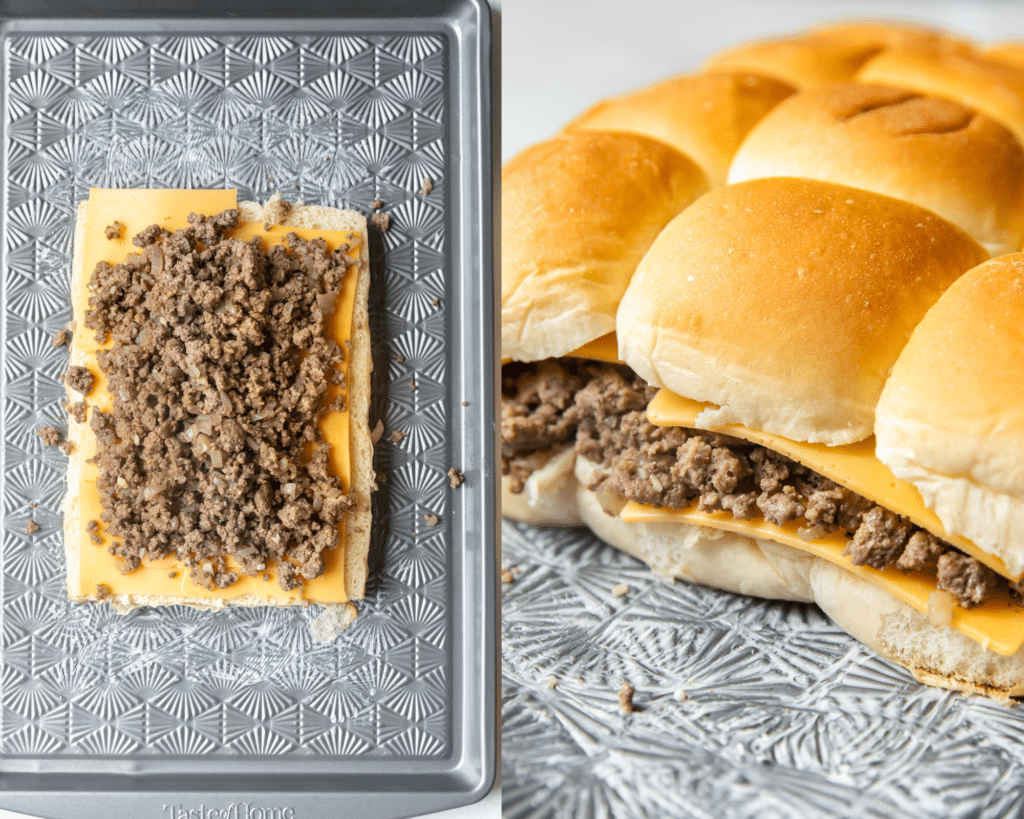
[620,501,1024,655]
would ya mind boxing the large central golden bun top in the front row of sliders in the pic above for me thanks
[616,178,987,445]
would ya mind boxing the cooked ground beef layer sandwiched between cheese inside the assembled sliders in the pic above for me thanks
[503,361,1019,608]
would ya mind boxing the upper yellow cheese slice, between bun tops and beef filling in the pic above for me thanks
[647,389,1021,580]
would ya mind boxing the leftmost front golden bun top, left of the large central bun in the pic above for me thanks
[502,132,708,361]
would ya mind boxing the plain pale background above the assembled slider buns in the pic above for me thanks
[502,0,1024,160]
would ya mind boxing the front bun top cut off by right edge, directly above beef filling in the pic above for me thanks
[874,253,1024,575]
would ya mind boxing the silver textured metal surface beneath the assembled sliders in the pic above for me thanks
[502,522,1024,819]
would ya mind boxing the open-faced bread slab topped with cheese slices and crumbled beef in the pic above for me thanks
[65,189,374,629]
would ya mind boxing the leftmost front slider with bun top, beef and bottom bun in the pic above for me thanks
[502,132,709,525]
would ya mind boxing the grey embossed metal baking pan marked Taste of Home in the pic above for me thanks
[0,0,497,819]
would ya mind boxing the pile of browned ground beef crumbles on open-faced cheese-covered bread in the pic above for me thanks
[86,210,362,590]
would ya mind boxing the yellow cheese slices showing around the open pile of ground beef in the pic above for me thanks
[69,188,361,603]
